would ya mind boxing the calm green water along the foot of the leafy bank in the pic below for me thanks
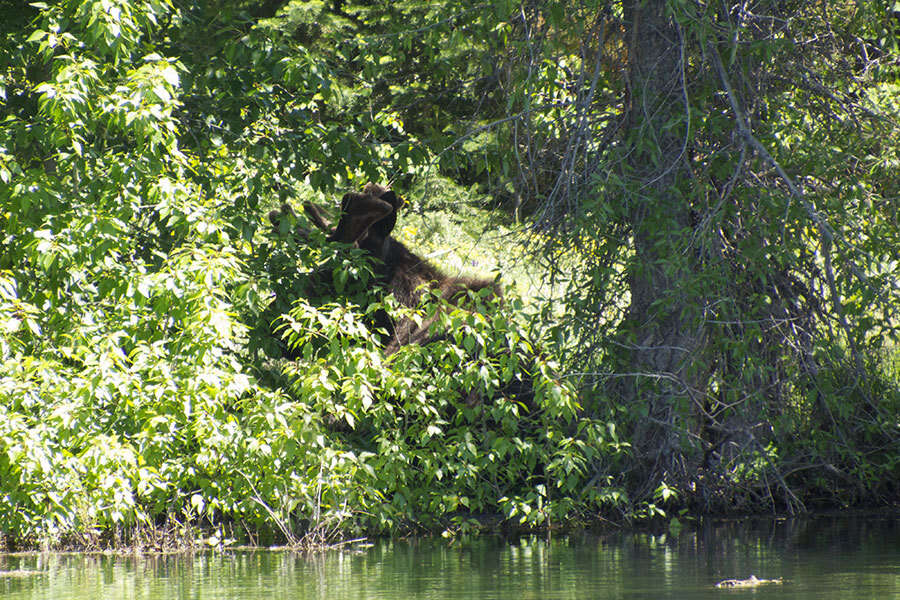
[0,517,900,600]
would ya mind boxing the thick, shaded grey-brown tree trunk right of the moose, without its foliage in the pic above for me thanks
[621,0,705,495]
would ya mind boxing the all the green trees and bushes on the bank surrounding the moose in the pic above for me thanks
[0,0,900,546]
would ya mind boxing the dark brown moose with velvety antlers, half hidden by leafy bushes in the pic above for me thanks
[269,183,501,355]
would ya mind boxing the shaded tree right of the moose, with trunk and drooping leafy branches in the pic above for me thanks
[492,2,900,511]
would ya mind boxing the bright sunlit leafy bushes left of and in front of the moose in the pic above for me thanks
[0,0,615,544]
